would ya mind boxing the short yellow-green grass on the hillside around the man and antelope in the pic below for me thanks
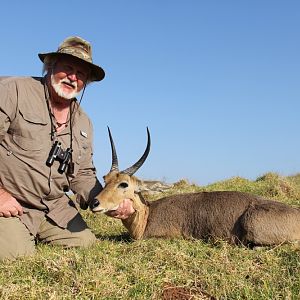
[0,173,300,299]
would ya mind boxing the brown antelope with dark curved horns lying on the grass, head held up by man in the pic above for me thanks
[90,128,300,247]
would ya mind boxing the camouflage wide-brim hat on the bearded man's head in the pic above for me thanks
[38,36,105,81]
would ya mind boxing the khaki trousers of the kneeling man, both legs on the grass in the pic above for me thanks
[0,214,96,261]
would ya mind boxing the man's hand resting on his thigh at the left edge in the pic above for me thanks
[0,189,23,218]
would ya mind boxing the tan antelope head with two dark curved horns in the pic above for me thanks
[91,127,151,213]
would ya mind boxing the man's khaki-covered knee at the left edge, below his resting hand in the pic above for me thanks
[0,217,35,261]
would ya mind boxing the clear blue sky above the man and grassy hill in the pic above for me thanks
[0,0,300,185]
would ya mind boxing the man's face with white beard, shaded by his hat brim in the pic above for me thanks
[51,57,89,99]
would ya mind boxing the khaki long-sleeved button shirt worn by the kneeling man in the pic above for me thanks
[0,77,102,235]
